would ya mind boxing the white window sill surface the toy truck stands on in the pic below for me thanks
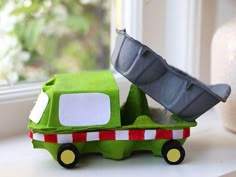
[0,111,236,177]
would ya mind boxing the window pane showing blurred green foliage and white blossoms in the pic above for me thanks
[0,0,110,84]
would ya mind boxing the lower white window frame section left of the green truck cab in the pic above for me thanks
[0,83,42,139]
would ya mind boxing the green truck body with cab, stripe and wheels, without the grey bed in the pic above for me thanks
[28,71,196,168]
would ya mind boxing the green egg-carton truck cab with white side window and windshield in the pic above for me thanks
[29,71,121,133]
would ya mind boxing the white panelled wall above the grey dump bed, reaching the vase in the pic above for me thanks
[143,0,236,83]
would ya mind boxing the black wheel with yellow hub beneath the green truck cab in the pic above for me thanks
[57,144,79,169]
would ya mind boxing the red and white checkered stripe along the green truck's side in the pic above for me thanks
[29,128,190,143]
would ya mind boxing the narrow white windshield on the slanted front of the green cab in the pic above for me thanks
[29,91,48,123]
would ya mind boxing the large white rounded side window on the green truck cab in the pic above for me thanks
[59,93,110,126]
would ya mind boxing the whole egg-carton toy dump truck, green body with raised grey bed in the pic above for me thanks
[28,31,230,168]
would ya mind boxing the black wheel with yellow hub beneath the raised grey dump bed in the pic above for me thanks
[161,140,185,165]
